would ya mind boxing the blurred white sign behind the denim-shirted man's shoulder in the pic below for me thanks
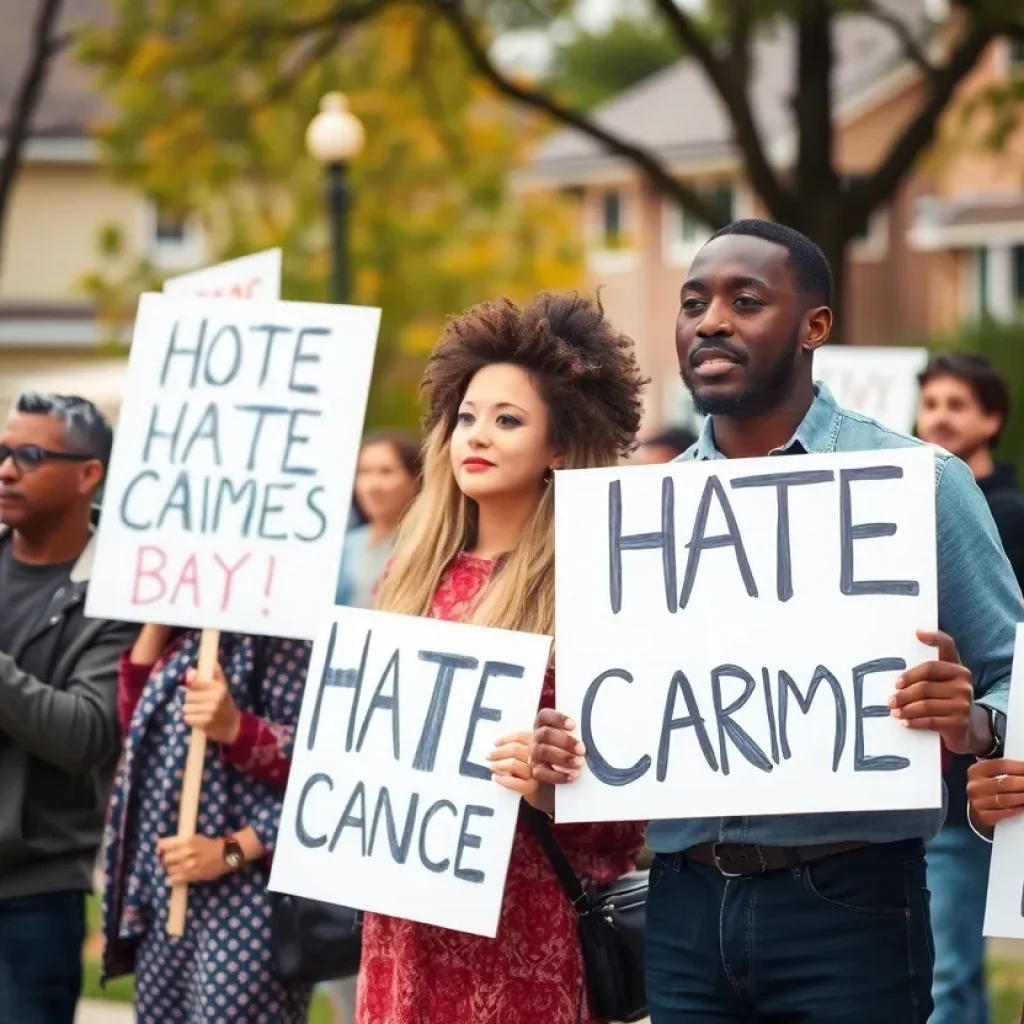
[814,345,928,434]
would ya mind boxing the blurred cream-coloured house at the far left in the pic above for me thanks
[0,0,206,416]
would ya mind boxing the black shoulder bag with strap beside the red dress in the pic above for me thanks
[523,802,648,1024]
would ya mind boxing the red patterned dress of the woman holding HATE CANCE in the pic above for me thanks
[355,555,644,1024]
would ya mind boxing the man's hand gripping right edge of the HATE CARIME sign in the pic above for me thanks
[889,630,976,754]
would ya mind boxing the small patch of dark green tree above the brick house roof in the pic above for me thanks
[545,17,679,111]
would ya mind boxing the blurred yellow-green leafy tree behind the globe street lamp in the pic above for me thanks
[75,0,579,426]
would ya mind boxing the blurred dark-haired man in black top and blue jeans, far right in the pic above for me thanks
[918,352,1024,1024]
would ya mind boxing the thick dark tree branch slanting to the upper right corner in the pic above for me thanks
[847,26,994,224]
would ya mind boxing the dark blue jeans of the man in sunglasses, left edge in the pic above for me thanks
[0,892,85,1024]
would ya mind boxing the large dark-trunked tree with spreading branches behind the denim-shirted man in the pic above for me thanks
[81,0,1024,342]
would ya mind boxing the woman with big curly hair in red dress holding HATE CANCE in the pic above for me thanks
[356,295,645,1024]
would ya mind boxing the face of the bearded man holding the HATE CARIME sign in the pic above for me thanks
[676,234,827,417]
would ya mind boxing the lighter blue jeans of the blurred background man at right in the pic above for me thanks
[927,825,991,1024]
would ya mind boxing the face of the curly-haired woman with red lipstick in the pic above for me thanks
[452,362,557,502]
